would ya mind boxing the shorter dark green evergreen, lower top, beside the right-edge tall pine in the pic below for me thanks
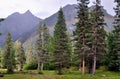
[105,33,120,71]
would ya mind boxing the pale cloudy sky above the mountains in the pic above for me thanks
[0,0,115,19]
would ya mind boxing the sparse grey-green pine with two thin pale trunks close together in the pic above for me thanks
[36,24,50,73]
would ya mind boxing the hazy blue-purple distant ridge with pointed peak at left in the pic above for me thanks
[0,10,42,45]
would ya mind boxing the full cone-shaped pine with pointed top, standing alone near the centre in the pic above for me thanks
[54,8,70,74]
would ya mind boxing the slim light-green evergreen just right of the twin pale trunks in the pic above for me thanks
[42,23,53,69]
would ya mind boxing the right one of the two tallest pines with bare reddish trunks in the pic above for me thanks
[92,0,106,75]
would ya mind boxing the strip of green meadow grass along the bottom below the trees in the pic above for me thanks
[0,71,120,79]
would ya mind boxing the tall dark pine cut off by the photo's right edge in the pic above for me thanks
[113,0,120,71]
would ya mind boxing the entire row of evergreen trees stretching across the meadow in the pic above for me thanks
[0,0,120,75]
